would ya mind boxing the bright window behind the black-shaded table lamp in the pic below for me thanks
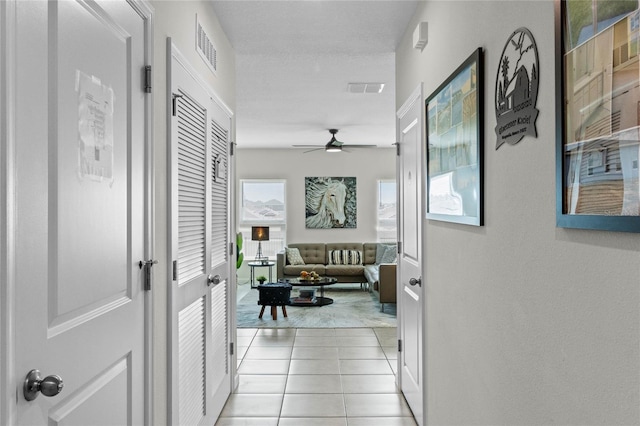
[238,179,287,260]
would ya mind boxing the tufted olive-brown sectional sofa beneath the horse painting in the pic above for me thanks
[276,243,396,310]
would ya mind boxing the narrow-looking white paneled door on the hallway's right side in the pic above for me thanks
[396,85,426,425]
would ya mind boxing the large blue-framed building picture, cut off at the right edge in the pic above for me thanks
[555,0,640,232]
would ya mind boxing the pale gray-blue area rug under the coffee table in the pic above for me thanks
[237,284,397,328]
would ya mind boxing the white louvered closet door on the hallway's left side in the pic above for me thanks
[168,40,234,426]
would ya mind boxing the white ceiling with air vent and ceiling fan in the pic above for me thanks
[212,0,417,148]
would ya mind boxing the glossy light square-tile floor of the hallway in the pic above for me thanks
[216,328,416,426]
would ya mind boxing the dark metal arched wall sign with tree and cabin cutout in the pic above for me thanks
[496,28,539,149]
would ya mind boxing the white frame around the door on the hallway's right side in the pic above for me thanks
[396,82,427,425]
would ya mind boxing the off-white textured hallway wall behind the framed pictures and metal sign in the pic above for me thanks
[396,0,640,425]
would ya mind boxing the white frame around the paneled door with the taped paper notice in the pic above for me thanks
[0,0,155,426]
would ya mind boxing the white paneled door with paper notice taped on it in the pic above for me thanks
[9,0,149,426]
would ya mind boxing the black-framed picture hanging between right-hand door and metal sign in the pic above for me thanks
[425,48,484,226]
